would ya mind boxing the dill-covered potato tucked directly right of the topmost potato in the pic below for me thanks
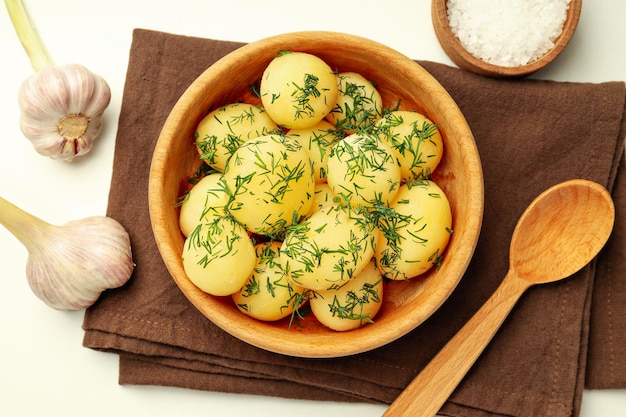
[326,72,383,134]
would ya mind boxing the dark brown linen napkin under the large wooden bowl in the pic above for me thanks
[84,29,626,417]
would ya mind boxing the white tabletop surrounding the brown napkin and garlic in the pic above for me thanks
[0,0,626,417]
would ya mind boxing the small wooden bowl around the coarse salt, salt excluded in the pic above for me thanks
[431,0,582,78]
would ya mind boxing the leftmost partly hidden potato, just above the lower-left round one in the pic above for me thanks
[179,173,228,236]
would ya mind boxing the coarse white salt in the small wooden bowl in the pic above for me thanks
[447,0,570,67]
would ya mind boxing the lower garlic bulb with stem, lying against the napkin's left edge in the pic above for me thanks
[0,197,134,310]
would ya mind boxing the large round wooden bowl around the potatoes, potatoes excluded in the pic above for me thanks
[149,32,483,357]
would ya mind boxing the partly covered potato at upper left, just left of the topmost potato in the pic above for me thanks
[195,103,277,172]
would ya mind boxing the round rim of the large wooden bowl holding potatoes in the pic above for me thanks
[148,31,484,358]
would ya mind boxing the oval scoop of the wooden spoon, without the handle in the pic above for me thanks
[510,180,614,284]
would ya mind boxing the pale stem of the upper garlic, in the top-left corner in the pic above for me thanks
[4,0,53,72]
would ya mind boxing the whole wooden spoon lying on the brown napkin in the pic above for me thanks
[384,180,615,417]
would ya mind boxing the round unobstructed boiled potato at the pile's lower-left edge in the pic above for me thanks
[182,217,256,296]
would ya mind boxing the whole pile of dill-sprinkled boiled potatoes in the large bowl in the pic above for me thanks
[180,52,452,331]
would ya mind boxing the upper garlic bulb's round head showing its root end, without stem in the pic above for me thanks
[18,64,111,162]
